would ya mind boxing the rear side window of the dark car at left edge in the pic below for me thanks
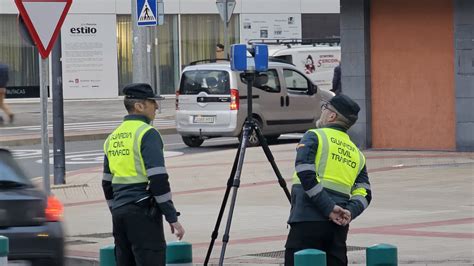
[0,149,32,188]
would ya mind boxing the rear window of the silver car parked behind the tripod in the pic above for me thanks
[179,70,230,95]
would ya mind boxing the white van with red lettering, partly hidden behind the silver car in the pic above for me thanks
[268,45,341,90]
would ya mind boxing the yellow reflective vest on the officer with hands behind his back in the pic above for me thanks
[293,128,365,196]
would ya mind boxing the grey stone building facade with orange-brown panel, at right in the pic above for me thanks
[341,0,474,151]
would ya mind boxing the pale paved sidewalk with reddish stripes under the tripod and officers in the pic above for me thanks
[39,147,474,265]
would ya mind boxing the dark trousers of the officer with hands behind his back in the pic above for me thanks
[285,221,349,266]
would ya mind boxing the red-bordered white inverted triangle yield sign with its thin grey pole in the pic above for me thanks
[15,0,72,194]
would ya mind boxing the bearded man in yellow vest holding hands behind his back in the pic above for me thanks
[285,94,372,266]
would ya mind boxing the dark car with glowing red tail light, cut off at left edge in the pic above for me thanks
[0,149,64,266]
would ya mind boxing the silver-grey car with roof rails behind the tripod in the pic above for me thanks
[176,60,334,147]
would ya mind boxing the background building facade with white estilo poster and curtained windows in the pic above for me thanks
[0,0,339,99]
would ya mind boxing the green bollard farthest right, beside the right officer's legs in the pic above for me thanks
[365,244,398,266]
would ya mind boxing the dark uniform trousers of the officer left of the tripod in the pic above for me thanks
[112,200,166,266]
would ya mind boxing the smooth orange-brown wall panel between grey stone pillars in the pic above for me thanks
[371,0,456,150]
